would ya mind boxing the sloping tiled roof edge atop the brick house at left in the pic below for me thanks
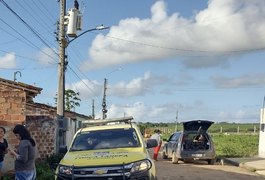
[0,78,42,97]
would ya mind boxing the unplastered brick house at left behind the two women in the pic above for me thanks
[0,78,88,172]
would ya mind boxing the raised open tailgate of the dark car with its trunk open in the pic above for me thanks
[183,120,214,132]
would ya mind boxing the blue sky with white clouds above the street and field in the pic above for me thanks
[0,0,265,123]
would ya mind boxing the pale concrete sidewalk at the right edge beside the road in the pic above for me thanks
[223,157,265,177]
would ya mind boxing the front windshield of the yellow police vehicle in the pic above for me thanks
[70,128,140,151]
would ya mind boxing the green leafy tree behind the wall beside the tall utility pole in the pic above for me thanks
[54,89,81,111]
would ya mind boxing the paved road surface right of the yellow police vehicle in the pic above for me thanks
[155,159,265,180]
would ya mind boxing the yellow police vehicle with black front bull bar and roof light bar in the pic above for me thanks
[56,117,157,180]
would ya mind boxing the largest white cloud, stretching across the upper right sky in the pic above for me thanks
[82,0,265,70]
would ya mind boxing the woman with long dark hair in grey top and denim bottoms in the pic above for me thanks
[9,124,36,180]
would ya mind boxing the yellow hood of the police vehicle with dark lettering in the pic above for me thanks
[60,148,148,166]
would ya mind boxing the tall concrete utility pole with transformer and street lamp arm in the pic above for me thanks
[56,0,109,152]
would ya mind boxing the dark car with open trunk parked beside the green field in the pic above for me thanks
[163,120,216,164]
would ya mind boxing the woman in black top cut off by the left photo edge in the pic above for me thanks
[0,126,8,178]
